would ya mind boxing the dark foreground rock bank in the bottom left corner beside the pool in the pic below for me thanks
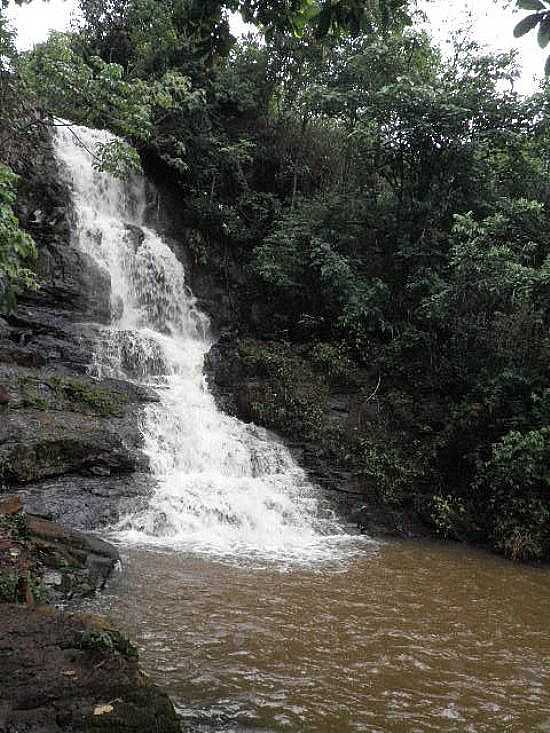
[0,606,180,733]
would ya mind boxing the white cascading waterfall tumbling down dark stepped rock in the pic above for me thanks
[52,126,354,559]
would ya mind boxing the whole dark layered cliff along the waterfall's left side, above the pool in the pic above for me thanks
[0,127,158,528]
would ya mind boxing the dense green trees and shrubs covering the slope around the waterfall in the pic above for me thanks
[0,0,550,559]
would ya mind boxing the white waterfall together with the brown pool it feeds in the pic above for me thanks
[55,126,550,733]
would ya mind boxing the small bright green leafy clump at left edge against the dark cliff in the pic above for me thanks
[0,163,36,309]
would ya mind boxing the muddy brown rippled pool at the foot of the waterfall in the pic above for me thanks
[88,542,550,733]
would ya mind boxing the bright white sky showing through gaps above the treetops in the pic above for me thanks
[5,0,550,91]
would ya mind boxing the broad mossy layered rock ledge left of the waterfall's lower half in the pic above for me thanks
[0,362,158,529]
